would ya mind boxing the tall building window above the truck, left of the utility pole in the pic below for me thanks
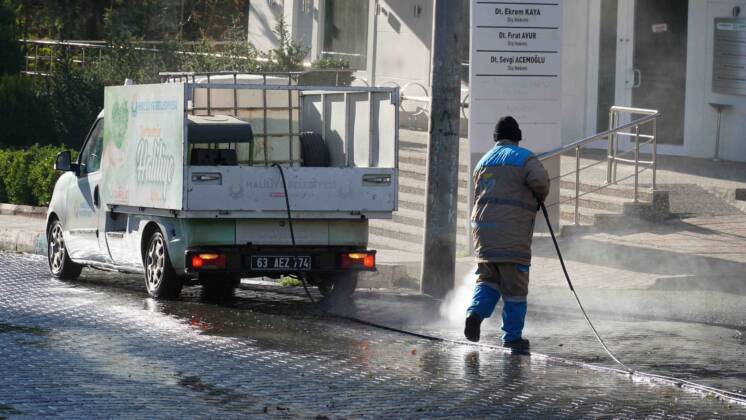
[321,0,368,70]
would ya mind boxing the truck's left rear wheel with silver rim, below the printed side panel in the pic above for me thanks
[142,229,184,299]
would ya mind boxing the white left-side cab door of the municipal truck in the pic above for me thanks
[65,119,108,262]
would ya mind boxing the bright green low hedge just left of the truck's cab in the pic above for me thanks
[0,145,73,206]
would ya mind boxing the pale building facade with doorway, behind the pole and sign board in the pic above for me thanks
[248,0,746,161]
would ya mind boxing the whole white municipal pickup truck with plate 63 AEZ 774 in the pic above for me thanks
[47,75,399,299]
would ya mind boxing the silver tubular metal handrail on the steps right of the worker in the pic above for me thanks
[537,106,660,225]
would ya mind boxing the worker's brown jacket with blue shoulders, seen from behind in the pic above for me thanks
[471,140,549,265]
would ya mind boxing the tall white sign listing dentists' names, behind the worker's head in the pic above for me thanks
[469,0,560,156]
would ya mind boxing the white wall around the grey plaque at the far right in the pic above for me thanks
[684,0,746,162]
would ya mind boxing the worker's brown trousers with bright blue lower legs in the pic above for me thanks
[467,263,528,341]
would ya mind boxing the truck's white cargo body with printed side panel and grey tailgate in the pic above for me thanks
[102,83,397,219]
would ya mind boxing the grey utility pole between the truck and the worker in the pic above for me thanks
[420,0,463,298]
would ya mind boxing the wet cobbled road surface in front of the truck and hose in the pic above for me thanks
[0,253,746,418]
